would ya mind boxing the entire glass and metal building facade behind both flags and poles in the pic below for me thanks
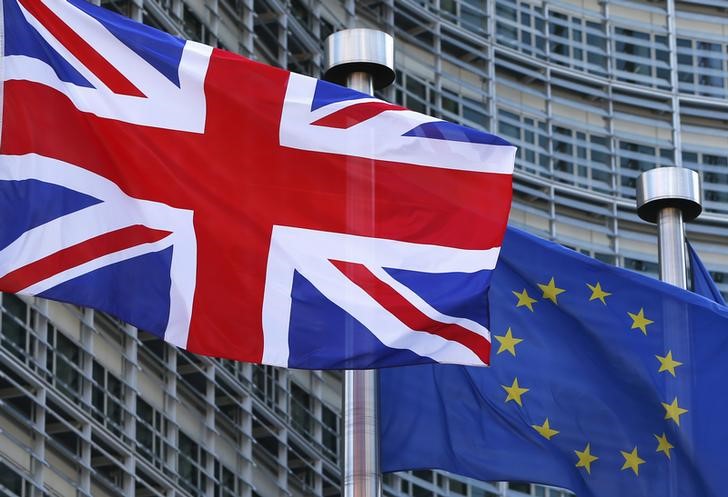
[0,0,728,497]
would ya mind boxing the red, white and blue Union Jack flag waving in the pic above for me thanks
[0,0,515,369]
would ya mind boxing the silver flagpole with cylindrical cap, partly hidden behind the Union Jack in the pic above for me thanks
[324,29,394,497]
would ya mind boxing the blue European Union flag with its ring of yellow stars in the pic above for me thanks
[380,229,728,497]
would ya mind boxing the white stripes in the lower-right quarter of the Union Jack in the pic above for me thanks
[263,226,499,366]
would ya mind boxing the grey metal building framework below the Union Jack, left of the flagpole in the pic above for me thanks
[0,294,341,497]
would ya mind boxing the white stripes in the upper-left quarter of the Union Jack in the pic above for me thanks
[6,0,212,133]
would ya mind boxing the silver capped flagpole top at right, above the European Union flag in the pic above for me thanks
[637,167,703,289]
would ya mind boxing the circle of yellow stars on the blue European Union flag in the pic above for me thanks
[506,277,688,476]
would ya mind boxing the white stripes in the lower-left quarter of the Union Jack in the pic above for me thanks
[0,154,197,347]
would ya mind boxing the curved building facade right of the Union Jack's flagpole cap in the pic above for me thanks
[370,0,728,293]
